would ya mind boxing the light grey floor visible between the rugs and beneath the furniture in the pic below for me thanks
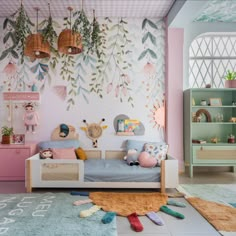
[0,170,236,236]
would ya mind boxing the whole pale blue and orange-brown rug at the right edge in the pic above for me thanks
[177,184,236,236]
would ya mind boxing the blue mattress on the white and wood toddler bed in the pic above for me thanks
[84,159,161,182]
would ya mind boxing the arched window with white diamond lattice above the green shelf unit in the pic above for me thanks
[189,33,236,88]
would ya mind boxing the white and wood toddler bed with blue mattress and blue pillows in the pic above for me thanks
[25,140,178,192]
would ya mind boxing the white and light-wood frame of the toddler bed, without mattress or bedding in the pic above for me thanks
[25,150,179,193]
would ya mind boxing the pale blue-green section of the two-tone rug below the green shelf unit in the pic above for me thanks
[177,184,236,206]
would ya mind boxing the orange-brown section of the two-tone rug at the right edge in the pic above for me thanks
[186,197,236,232]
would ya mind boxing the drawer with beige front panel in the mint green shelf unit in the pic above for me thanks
[193,145,236,164]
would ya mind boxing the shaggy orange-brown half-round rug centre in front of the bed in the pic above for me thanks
[89,192,168,216]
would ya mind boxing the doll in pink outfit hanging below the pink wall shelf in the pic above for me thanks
[23,102,39,134]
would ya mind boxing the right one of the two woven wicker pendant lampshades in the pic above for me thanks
[57,29,83,54]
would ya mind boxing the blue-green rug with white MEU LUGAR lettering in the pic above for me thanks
[0,193,117,236]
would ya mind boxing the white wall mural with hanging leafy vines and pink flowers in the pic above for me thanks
[0,14,165,148]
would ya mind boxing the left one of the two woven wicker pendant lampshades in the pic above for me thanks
[24,33,50,59]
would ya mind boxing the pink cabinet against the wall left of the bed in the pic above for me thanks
[0,148,30,180]
